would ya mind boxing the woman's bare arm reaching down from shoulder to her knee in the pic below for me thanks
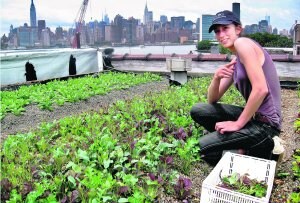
[216,38,268,133]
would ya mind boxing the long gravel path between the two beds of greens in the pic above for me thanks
[1,79,169,141]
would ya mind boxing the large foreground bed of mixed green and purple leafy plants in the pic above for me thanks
[1,78,242,202]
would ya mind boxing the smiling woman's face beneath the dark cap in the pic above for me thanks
[214,24,242,49]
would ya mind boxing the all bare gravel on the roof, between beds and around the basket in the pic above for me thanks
[1,79,300,203]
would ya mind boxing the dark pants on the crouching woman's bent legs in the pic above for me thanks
[191,103,280,165]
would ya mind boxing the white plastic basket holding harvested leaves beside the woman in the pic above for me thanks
[200,152,276,203]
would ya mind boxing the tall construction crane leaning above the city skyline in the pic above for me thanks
[72,0,89,49]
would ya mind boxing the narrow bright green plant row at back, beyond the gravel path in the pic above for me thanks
[0,72,161,120]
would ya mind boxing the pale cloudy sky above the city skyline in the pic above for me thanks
[0,0,300,36]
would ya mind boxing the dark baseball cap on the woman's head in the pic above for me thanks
[208,10,242,33]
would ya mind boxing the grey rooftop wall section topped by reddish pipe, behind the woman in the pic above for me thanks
[112,54,300,81]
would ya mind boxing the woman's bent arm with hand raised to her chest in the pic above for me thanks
[207,59,236,104]
